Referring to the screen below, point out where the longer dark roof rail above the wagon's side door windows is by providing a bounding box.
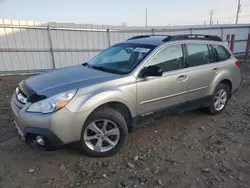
[163,34,222,42]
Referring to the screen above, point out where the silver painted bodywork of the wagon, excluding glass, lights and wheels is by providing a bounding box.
[12,39,241,143]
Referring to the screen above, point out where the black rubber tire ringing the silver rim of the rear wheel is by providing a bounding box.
[208,83,230,115]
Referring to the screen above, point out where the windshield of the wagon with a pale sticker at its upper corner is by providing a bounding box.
[88,44,154,74]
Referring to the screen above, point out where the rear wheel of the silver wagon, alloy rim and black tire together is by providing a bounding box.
[209,83,230,115]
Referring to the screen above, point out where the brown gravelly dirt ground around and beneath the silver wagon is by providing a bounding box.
[0,64,250,188]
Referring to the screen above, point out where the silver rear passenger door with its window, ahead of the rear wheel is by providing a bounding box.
[185,42,219,105]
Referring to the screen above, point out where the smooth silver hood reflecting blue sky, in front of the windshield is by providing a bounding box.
[22,65,121,97]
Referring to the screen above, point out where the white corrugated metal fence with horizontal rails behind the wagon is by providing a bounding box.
[0,19,250,75]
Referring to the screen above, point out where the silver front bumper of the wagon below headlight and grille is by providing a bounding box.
[11,94,90,147]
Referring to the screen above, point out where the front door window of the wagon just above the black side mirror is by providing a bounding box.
[150,45,184,72]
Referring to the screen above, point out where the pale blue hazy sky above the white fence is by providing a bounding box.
[0,0,250,26]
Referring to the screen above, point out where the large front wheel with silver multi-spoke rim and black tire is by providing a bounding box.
[80,107,128,157]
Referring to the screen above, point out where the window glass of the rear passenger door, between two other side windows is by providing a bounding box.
[186,44,214,67]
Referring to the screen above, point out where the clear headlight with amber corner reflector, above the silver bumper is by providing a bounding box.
[27,90,77,114]
